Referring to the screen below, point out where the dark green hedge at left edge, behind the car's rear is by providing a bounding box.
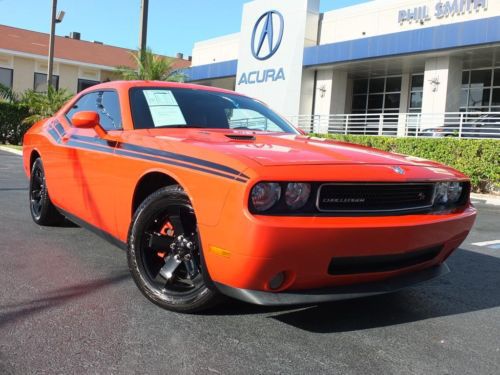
[0,101,29,145]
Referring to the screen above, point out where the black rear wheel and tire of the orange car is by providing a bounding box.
[29,158,64,226]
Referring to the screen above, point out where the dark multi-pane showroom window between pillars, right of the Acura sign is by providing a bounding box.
[352,76,401,114]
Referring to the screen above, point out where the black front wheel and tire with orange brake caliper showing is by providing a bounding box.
[127,185,220,313]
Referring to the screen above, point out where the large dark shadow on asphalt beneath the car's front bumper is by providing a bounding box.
[209,249,500,333]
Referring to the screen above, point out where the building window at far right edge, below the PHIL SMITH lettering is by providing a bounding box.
[460,67,500,112]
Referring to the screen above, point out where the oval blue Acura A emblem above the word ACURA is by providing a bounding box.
[252,10,285,60]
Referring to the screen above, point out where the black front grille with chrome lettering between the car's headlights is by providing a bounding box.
[316,183,434,213]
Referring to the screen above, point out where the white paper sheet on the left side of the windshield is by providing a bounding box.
[143,90,187,127]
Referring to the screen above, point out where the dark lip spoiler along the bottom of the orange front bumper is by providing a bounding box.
[215,263,450,306]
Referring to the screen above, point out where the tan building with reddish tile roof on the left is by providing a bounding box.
[0,25,191,93]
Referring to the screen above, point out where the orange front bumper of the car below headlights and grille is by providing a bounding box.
[199,206,476,294]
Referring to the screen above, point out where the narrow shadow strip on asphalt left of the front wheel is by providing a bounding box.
[0,271,130,328]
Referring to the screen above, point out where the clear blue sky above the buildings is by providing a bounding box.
[0,0,369,56]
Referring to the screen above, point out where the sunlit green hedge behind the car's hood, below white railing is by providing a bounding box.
[316,134,500,193]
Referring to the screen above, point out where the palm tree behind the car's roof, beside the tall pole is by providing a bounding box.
[117,48,186,82]
